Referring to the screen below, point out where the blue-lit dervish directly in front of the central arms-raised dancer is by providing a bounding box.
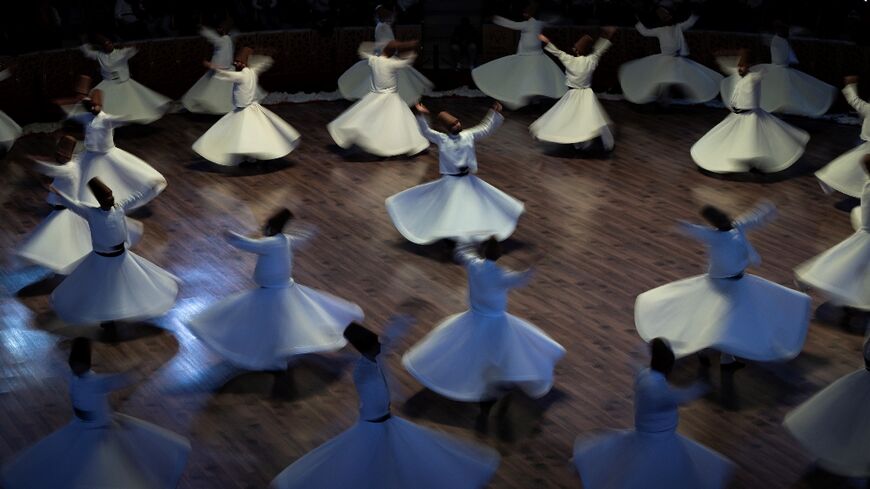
[402,238,565,404]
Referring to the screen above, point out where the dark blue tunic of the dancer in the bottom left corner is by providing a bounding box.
[69,370,129,427]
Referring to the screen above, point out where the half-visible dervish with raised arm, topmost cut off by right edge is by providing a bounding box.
[816,76,870,198]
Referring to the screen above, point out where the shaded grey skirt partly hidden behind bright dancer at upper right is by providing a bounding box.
[721,64,838,117]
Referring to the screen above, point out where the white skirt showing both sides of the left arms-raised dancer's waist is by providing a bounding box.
[17,209,144,275]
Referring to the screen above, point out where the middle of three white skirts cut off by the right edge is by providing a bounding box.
[795,230,870,310]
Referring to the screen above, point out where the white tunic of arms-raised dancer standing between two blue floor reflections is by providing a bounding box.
[57,190,147,253]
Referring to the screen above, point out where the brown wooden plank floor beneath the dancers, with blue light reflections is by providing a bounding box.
[0,98,862,489]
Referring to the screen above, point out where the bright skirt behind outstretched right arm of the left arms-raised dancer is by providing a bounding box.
[78,148,166,208]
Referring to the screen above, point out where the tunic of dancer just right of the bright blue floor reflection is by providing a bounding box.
[227,233,310,288]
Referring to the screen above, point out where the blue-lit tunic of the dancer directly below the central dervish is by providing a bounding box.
[456,246,532,316]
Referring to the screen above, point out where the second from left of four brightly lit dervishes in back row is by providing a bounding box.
[326,41,429,157]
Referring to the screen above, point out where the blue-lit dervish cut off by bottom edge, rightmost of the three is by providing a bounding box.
[573,338,734,489]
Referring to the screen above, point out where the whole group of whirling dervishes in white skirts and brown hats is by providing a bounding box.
[0,5,870,489]
